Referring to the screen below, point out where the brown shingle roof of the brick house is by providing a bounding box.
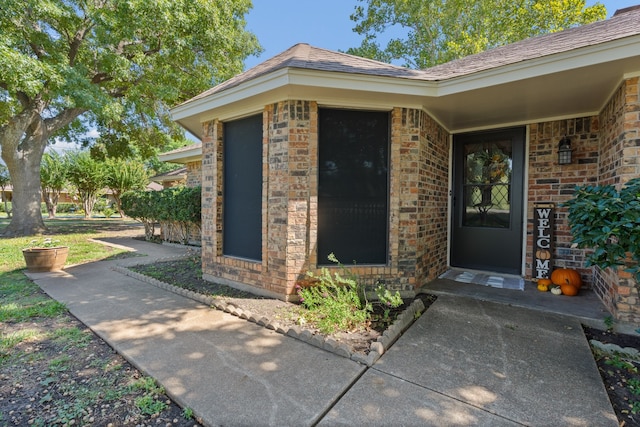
[183,8,640,105]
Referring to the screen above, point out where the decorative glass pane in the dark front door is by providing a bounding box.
[462,140,513,228]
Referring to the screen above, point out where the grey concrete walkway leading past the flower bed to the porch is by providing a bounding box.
[28,239,618,427]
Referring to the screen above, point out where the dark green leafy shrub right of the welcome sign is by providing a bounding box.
[564,178,640,283]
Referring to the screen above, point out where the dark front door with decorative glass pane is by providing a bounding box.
[451,128,525,274]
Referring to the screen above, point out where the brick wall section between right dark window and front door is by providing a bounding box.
[391,108,449,287]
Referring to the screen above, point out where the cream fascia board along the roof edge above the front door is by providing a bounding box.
[437,36,640,96]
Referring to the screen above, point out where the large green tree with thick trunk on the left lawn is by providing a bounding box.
[0,0,260,236]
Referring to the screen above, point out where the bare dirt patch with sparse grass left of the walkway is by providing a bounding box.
[0,304,198,427]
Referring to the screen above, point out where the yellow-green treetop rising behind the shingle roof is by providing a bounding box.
[348,0,606,68]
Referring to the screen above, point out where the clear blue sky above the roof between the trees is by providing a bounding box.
[245,0,640,69]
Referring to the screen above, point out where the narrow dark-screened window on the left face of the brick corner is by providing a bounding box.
[222,115,262,260]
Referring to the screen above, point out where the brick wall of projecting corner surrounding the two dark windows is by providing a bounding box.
[202,100,449,300]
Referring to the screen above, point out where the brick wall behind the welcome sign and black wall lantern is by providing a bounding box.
[526,117,600,284]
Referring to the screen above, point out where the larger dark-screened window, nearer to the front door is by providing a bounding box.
[318,109,389,264]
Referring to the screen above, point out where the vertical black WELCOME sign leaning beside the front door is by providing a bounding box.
[533,203,555,279]
